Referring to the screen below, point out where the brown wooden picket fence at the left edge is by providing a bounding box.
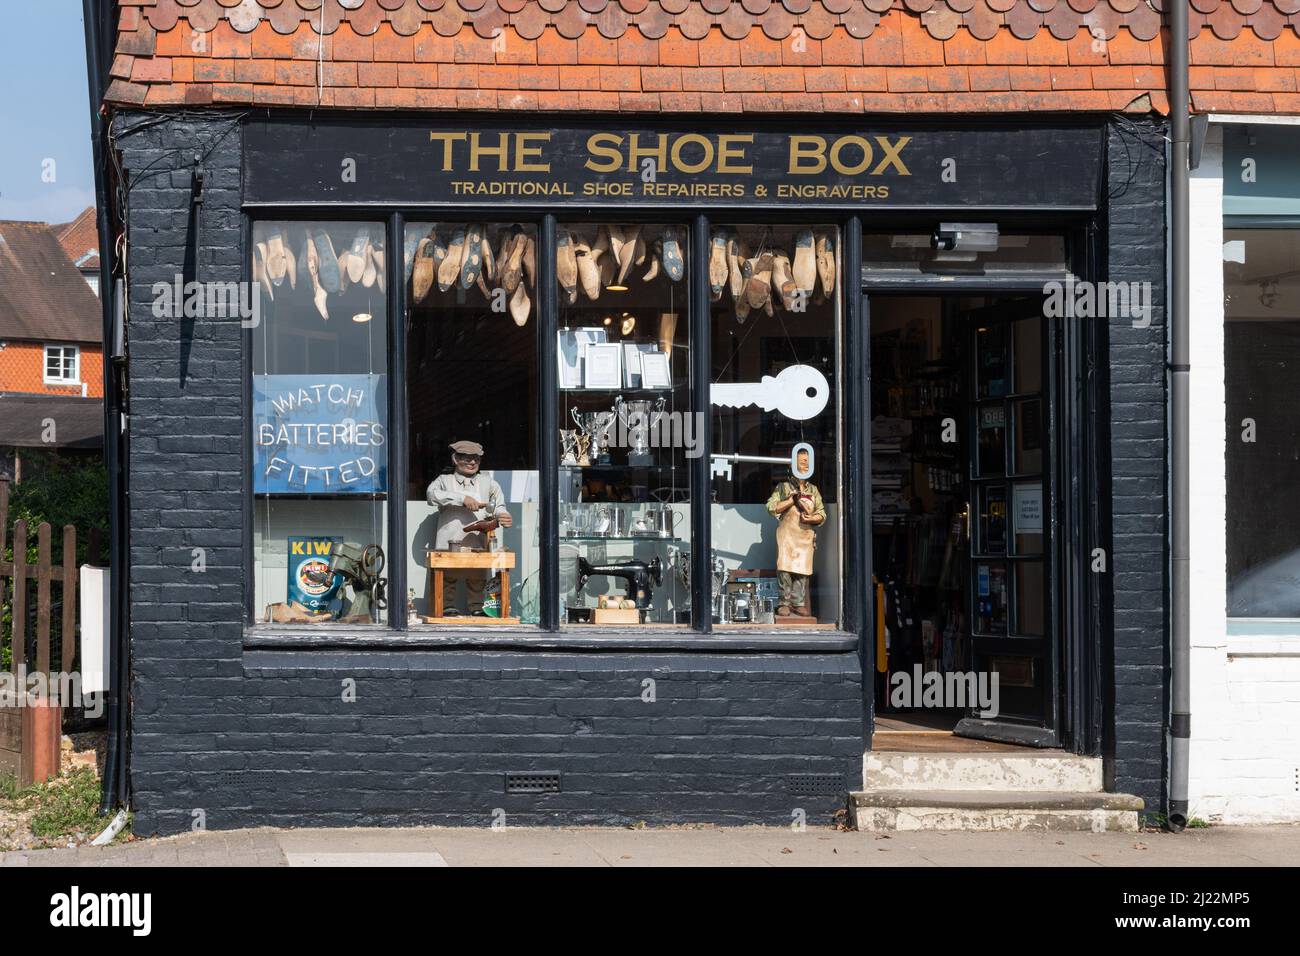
[0,479,99,786]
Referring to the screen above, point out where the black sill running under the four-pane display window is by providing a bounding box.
[244,624,858,654]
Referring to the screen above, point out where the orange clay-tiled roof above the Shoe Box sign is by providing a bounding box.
[109,0,1300,112]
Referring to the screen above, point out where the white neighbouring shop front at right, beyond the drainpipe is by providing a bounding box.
[1188,114,1300,823]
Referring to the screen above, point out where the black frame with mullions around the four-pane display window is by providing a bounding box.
[241,204,870,642]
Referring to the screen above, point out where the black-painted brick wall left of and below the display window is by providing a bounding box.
[117,108,862,834]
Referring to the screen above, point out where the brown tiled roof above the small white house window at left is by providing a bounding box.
[0,221,103,342]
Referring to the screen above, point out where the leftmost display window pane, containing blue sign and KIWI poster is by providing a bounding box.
[251,222,389,624]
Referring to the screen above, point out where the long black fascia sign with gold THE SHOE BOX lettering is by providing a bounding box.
[244,117,1102,209]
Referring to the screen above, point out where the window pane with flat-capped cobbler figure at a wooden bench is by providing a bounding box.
[403,222,540,626]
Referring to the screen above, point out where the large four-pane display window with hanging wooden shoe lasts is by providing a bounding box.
[252,219,842,636]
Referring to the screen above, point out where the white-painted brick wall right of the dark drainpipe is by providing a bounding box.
[1190,125,1300,823]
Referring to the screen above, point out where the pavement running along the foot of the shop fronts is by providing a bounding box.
[0,825,1300,866]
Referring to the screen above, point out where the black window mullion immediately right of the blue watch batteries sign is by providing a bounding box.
[384,213,405,631]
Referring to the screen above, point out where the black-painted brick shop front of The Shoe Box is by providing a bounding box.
[118,113,1165,831]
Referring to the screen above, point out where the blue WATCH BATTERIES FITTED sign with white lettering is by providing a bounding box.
[252,375,389,494]
